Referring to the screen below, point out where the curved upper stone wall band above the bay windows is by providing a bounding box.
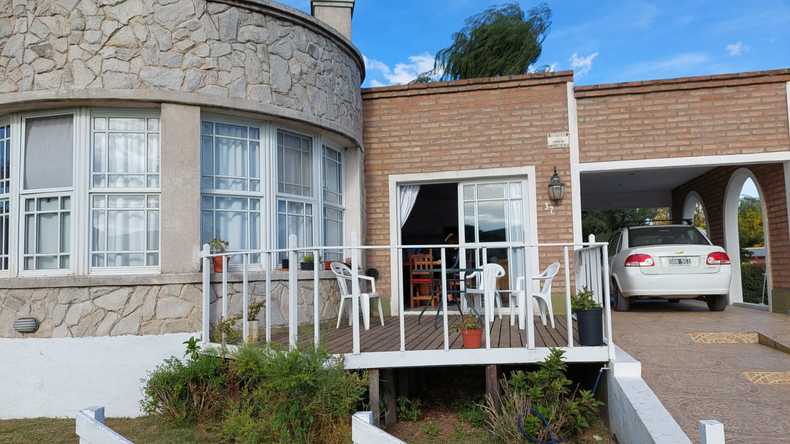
[0,0,362,141]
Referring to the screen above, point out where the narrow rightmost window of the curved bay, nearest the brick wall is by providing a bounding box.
[322,146,344,261]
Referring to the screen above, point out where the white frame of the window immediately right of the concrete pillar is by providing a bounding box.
[199,114,273,269]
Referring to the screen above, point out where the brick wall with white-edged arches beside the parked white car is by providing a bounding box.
[672,163,790,306]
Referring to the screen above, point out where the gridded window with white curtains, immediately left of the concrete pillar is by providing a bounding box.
[89,114,160,269]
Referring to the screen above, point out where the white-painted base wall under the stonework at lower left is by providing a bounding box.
[0,333,199,419]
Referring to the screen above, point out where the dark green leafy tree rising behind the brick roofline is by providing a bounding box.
[434,2,551,80]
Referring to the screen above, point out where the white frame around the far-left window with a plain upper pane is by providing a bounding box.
[16,109,85,277]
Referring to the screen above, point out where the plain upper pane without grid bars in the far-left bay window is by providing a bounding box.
[24,115,74,190]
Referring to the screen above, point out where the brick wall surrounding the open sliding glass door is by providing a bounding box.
[363,73,573,308]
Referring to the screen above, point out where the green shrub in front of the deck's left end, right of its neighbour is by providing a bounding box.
[223,347,366,443]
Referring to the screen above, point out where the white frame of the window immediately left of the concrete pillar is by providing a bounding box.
[89,108,163,275]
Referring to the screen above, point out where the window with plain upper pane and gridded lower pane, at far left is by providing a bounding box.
[20,114,74,271]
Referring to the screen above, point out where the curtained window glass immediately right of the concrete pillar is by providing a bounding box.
[201,121,265,260]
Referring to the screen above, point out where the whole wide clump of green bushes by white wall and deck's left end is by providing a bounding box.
[142,341,367,443]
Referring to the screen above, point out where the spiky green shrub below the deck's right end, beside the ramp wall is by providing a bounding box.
[485,349,602,442]
